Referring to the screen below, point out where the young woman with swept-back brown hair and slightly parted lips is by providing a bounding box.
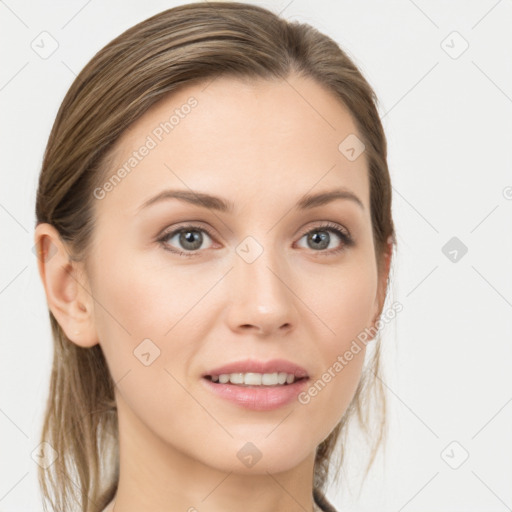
[35,2,395,512]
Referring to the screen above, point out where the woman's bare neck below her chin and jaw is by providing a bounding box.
[109,390,317,512]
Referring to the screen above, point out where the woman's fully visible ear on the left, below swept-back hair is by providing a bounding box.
[34,223,98,348]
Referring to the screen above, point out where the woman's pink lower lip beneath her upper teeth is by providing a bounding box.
[201,378,309,411]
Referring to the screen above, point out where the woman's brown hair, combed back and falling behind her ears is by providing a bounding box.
[36,2,396,512]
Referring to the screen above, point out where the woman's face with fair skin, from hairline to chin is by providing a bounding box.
[83,76,381,473]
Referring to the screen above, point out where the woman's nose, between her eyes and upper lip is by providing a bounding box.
[227,249,298,337]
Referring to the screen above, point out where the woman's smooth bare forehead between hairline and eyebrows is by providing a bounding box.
[97,76,369,219]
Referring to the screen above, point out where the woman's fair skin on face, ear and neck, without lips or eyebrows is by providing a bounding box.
[35,75,389,512]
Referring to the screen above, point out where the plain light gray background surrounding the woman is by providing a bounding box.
[0,0,512,512]
